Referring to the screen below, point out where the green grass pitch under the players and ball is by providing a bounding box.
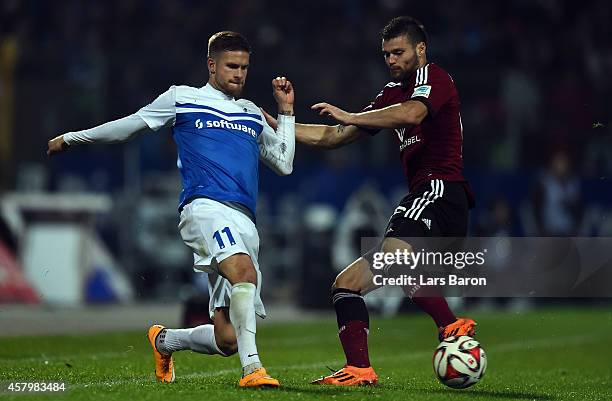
[0,308,612,401]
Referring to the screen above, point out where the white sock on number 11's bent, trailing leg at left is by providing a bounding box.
[155,324,224,355]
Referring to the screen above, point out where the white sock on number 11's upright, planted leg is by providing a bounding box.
[230,283,262,376]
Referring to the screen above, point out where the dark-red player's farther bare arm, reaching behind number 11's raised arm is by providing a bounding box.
[262,109,368,149]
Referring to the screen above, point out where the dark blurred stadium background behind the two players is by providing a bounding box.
[0,0,612,334]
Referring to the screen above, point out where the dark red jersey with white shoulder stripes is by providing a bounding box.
[364,63,473,203]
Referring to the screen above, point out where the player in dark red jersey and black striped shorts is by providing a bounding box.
[267,17,475,385]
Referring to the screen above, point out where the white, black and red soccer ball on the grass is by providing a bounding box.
[433,336,487,388]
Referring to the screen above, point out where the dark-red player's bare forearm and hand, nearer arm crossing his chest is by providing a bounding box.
[312,100,428,129]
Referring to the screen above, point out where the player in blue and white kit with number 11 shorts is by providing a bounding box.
[47,31,295,387]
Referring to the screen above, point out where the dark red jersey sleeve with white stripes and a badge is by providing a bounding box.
[410,65,455,117]
